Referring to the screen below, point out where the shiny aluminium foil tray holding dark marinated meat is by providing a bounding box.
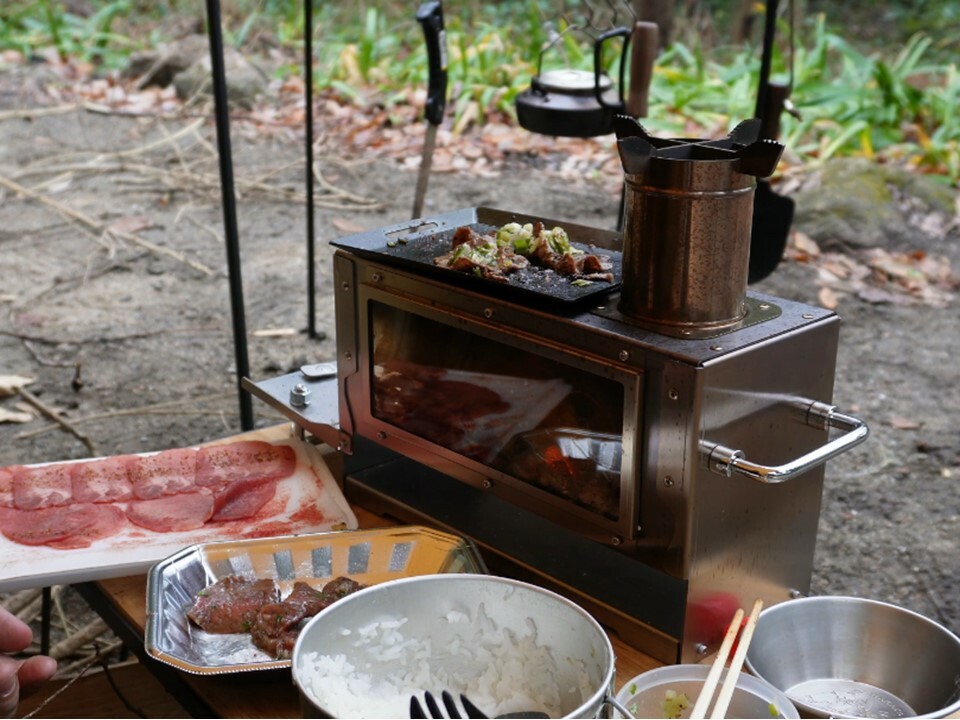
[144,526,487,675]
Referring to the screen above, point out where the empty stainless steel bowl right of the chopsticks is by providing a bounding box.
[747,597,960,718]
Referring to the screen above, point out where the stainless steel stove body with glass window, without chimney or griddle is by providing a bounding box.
[249,204,867,662]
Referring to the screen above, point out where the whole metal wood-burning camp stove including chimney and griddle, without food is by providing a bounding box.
[245,120,868,662]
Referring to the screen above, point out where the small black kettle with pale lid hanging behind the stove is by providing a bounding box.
[517,27,631,137]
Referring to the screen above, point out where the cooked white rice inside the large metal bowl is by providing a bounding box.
[299,604,594,718]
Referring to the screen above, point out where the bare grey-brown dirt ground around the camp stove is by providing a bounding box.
[0,76,960,676]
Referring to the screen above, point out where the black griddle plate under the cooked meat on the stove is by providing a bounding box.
[331,207,623,305]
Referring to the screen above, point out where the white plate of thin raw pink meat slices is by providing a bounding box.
[0,426,357,592]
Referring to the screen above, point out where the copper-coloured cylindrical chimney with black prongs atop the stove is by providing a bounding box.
[615,116,783,337]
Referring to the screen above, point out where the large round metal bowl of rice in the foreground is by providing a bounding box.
[293,574,615,717]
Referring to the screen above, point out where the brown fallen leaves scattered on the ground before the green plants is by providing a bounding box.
[7,52,960,309]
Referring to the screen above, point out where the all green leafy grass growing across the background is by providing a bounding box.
[0,0,960,184]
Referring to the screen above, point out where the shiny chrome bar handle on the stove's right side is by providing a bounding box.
[700,401,870,485]
